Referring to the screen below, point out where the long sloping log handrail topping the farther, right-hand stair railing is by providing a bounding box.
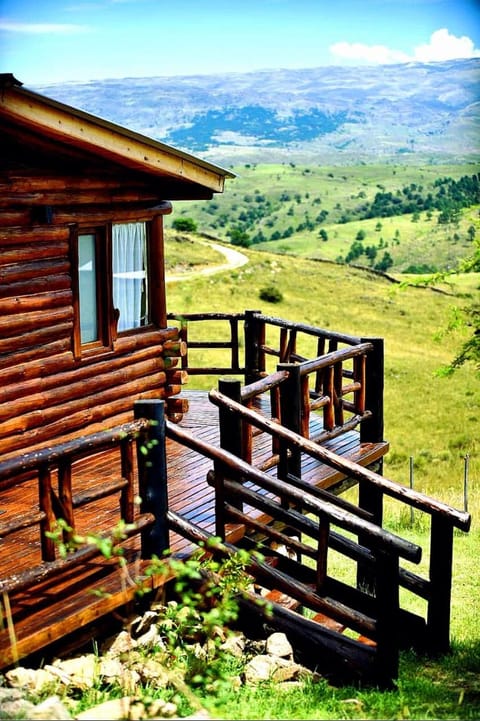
[208,389,471,531]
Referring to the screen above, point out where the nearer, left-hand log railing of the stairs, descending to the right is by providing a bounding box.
[166,414,421,685]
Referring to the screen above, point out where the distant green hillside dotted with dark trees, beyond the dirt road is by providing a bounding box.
[167,163,480,273]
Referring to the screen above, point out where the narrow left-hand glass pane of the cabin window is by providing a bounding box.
[78,233,98,343]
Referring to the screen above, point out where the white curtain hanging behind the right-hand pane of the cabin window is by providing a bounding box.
[112,223,148,331]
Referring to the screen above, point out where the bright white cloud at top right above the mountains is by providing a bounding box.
[330,28,480,65]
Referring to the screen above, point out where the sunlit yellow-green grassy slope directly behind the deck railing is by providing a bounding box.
[166,234,480,506]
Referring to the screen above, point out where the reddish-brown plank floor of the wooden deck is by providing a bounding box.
[0,391,388,667]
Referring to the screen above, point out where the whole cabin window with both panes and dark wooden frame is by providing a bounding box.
[72,219,159,357]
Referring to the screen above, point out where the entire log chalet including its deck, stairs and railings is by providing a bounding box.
[0,75,470,684]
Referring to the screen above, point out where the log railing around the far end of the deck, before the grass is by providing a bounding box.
[169,310,384,450]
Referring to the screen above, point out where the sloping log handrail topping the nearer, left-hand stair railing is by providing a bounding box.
[165,420,421,563]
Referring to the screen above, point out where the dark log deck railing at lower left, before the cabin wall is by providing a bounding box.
[0,414,163,592]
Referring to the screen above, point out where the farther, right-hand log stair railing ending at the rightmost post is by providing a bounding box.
[209,390,471,652]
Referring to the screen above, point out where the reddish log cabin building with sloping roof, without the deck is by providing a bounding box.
[0,75,233,456]
